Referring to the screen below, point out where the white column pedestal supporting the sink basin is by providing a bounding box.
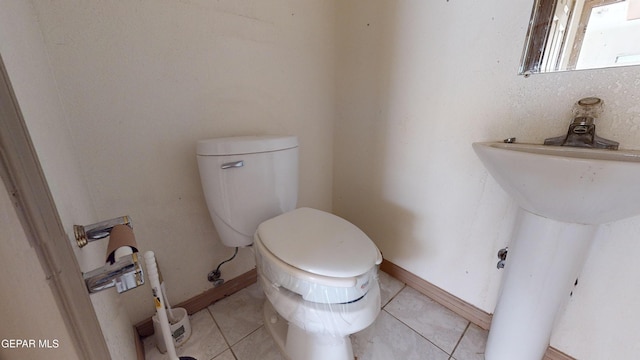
[485,209,598,360]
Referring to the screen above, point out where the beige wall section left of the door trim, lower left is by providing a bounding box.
[0,180,79,360]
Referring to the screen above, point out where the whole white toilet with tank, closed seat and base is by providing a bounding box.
[197,136,382,360]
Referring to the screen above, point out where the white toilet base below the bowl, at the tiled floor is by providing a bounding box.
[263,299,354,360]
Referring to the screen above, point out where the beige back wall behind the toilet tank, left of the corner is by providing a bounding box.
[34,0,335,322]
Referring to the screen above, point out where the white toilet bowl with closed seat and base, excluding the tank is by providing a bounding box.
[254,208,382,360]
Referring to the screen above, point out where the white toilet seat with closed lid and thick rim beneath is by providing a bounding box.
[254,208,382,303]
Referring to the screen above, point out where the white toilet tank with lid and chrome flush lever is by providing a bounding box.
[197,136,298,247]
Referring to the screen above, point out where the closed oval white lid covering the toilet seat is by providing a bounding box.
[256,208,382,277]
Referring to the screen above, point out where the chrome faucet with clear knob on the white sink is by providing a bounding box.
[544,97,619,150]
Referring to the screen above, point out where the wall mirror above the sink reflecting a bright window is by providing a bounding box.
[519,0,640,76]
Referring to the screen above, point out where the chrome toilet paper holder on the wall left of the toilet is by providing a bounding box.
[73,216,144,293]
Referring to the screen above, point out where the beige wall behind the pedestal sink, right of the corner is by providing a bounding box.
[333,0,640,360]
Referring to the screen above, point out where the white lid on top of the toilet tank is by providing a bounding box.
[196,135,298,156]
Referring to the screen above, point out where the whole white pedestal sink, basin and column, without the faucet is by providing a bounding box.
[473,142,640,360]
